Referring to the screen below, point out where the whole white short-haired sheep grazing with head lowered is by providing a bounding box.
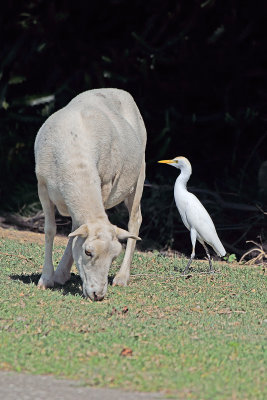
[35,89,146,300]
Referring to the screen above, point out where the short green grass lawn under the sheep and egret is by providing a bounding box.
[0,239,267,400]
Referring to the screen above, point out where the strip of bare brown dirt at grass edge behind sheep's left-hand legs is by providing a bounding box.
[0,227,68,246]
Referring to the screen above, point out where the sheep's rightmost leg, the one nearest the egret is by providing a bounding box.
[113,158,145,286]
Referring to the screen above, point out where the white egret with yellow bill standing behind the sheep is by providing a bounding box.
[158,157,226,274]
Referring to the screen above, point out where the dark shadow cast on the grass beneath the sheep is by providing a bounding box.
[10,273,114,297]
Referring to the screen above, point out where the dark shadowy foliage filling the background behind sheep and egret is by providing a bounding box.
[0,0,267,252]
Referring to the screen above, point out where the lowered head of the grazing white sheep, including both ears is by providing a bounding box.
[69,223,140,301]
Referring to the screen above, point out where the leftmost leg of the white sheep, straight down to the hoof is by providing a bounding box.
[38,183,56,289]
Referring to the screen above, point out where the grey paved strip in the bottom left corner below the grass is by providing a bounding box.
[0,371,164,400]
